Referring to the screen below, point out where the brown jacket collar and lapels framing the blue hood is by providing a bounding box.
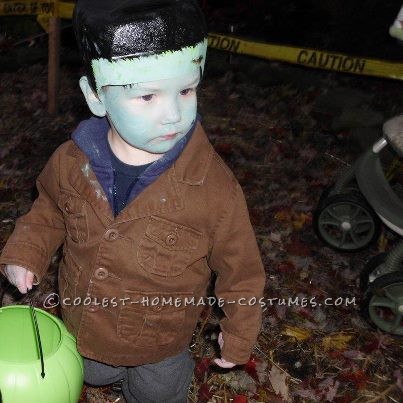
[67,122,214,226]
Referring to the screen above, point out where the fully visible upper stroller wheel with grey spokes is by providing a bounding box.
[313,192,380,252]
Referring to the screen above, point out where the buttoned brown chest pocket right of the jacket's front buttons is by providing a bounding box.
[137,217,202,277]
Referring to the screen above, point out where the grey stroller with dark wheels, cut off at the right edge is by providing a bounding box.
[313,116,403,336]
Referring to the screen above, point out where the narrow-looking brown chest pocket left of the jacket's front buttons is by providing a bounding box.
[58,193,88,243]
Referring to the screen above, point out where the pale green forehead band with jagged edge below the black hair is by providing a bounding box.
[92,39,207,92]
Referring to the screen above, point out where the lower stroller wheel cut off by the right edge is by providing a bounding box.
[361,271,403,336]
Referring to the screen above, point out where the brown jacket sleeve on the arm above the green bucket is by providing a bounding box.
[0,151,65,282]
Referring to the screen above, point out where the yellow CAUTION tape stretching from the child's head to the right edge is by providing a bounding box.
[209,33,403,80]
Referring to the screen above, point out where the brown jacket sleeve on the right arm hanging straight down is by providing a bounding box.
[209,183,265,364]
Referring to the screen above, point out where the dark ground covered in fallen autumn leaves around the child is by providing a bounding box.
[0,52,403,403]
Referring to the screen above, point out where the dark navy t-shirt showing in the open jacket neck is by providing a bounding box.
[108,142,152,217]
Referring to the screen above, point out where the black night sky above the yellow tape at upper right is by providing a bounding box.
[205,0,403,59]
